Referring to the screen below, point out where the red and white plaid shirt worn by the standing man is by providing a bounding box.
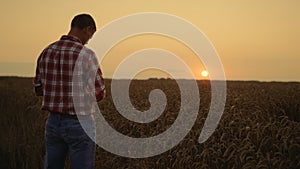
[33,35,105,115]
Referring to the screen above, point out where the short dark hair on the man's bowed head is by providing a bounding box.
[71,14,96,31]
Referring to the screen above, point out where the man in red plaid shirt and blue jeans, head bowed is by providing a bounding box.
[33,14,105,169]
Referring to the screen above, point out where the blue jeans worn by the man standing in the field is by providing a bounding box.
[44,114,96,169]
